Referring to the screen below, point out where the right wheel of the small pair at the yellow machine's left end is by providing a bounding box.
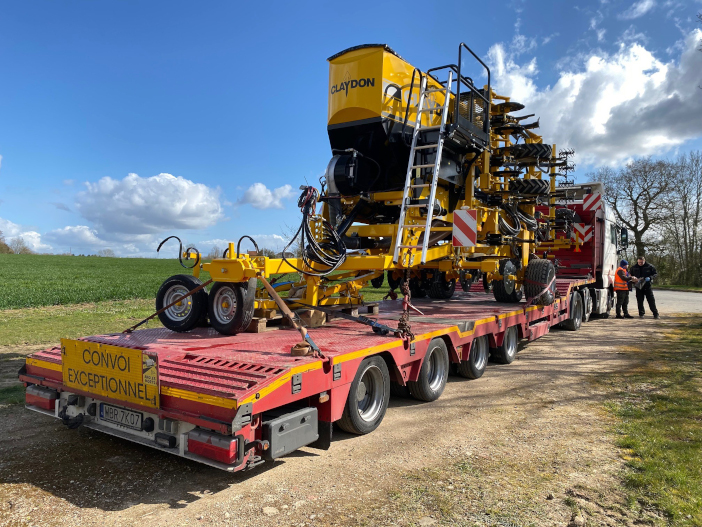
[208,278,256,335]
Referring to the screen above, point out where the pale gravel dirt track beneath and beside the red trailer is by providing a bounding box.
[0,292,702,527]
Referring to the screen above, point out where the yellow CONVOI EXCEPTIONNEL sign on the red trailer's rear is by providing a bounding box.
[61,339,159,408]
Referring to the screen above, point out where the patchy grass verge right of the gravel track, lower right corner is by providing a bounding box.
[608,317,702,525]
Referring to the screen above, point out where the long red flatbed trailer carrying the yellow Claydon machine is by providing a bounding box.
[19,276,595,471]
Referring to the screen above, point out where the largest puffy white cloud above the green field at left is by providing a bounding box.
[76,174,224,235]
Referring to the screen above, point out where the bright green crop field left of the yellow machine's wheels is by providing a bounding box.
[0,254,209,309]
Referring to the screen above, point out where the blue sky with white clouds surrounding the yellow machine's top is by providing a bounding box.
[0,0,702,256]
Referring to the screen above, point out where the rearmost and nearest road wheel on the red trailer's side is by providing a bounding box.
[337,356,390,434]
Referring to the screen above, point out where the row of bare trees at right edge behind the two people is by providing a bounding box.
[588,150,702,286]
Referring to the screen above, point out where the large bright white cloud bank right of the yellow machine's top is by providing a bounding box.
[488,29,702,165]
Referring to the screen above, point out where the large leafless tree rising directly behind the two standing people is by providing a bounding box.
[588,157,672,255]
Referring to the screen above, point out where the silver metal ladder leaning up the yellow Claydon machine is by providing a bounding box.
[392,71,453,267]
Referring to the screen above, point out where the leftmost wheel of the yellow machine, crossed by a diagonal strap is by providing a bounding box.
[156,274,207,332]
